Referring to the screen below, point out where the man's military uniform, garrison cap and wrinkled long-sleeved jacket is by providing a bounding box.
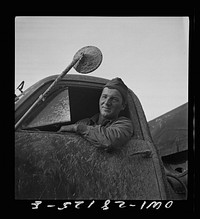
[58,78,133,149]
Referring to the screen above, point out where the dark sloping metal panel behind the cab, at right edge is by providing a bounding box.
[149,103,188,156]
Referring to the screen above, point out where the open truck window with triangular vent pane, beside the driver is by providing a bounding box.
[22,86,129,131]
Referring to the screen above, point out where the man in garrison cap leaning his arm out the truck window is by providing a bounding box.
[59,78,133,149]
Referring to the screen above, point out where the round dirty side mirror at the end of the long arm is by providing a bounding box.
[74,46,102,74]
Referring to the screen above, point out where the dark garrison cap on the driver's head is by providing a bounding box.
[104,78,128,104]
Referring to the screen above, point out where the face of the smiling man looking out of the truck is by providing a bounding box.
[99,87,125,119]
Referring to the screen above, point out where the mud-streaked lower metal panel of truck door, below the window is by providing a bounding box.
[15,131,162,200]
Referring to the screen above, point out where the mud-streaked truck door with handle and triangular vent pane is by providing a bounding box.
[15,81,170,200]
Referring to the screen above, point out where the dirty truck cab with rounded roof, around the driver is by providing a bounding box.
[15,74,183,200]
